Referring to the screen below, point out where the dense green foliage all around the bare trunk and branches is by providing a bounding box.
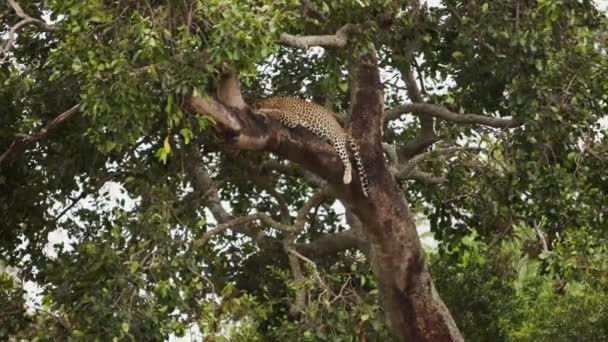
[0,0,608,341]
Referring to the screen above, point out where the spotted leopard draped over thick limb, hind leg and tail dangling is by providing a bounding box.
[256,97,369,196]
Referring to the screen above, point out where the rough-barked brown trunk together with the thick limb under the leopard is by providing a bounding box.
[188,65,462,341]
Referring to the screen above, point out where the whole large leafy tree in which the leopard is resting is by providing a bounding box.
[0,0,608,341]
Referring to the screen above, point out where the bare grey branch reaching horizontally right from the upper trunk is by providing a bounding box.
[386,103,523,128]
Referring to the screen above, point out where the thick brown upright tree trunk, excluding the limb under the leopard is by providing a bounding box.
[349,53,463,342]
